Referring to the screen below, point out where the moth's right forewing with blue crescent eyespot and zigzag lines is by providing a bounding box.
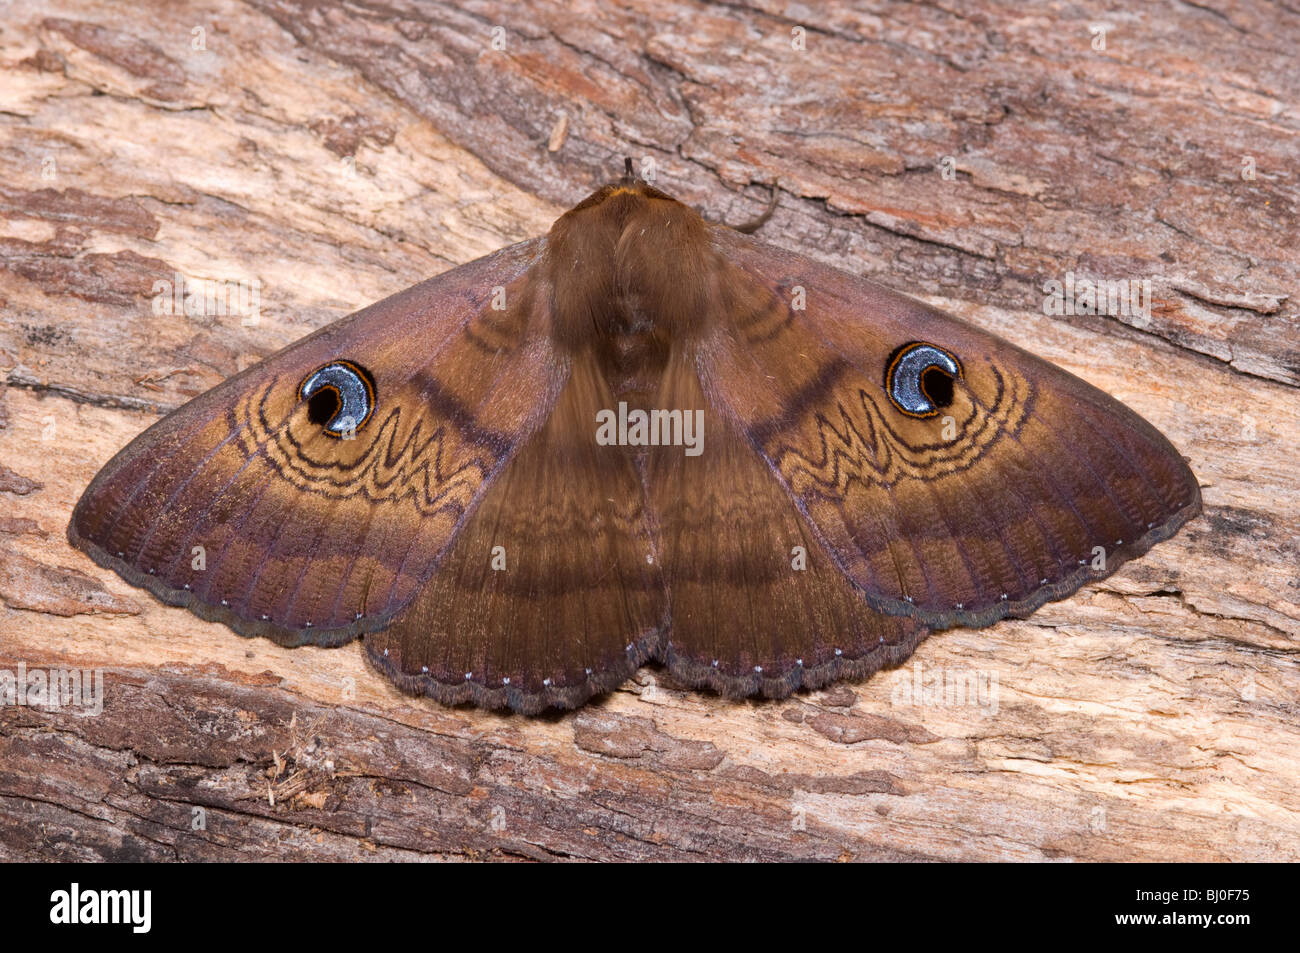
[697,228,1200,627]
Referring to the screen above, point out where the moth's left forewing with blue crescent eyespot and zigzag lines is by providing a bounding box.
[68,239,563,645]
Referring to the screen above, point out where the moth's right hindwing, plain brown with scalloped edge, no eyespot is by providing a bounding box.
[647,348,927,698]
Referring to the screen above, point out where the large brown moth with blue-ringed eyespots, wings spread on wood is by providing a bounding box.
[68,161,1200,714]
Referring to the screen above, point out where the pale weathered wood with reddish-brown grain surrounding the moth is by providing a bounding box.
[0,0,1300,861]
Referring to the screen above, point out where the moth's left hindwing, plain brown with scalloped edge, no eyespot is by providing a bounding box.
[365,354,666,714]
